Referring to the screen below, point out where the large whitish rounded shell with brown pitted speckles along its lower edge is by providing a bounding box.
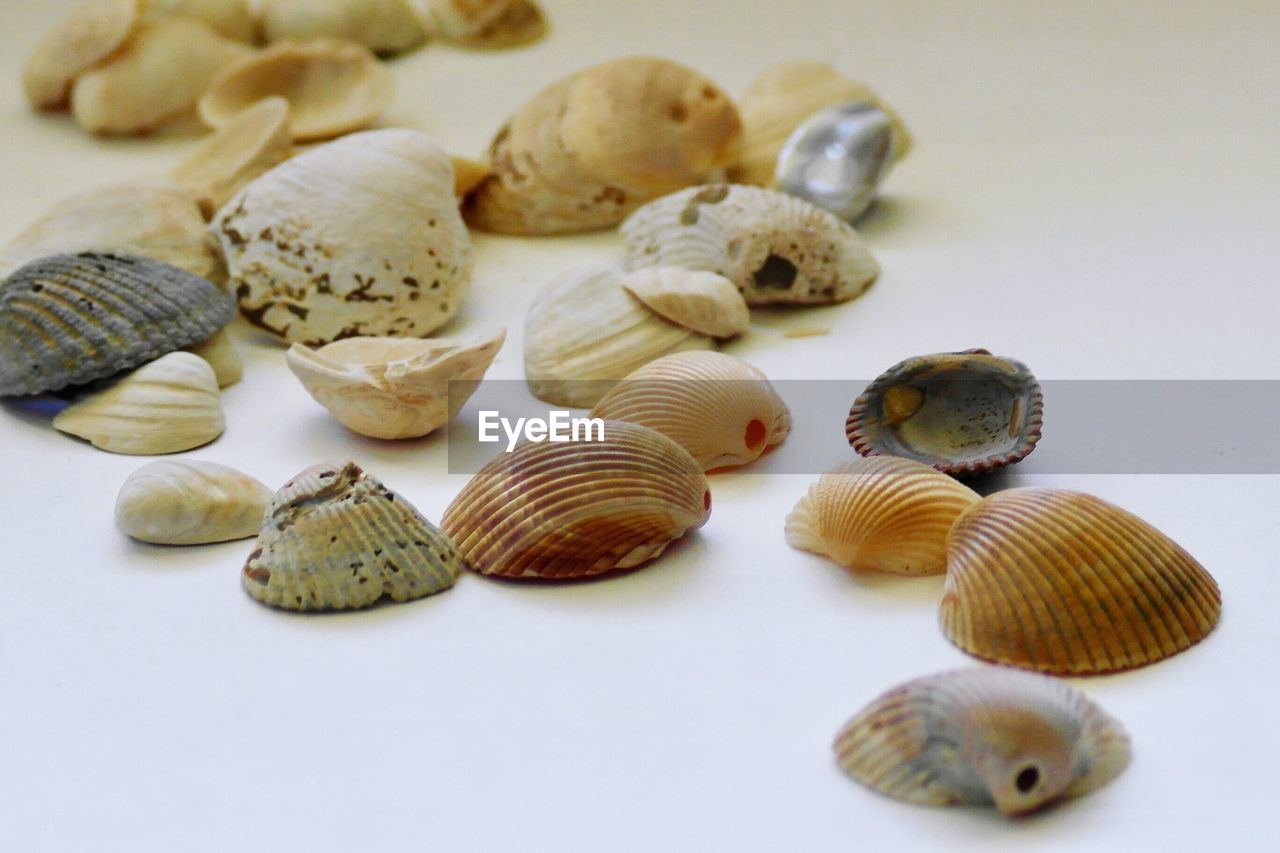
[211,129,472,346]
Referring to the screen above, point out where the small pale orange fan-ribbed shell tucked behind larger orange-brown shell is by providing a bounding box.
[786,456,982,575]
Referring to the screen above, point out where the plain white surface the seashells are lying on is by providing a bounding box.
[0,0,1280,850]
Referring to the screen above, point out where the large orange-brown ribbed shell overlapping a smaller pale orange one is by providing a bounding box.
[942,488,1222,675]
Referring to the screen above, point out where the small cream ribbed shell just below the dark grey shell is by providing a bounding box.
[54,352,227,456]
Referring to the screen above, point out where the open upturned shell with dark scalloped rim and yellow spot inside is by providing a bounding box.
[845,350,1043,475]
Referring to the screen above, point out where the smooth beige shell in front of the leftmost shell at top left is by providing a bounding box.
[72,15,252,134]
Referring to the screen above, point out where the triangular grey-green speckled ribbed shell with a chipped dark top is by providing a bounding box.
[241,462,462,611]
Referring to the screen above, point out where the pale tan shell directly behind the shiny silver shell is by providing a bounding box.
[728,60,911,187]
